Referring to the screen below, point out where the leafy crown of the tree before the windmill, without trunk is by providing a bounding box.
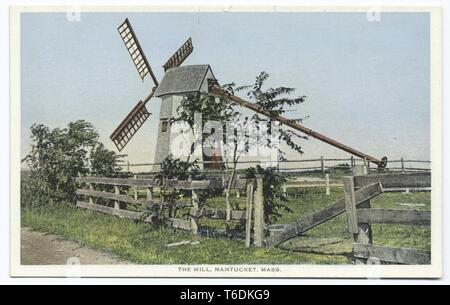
[171,72,308,163]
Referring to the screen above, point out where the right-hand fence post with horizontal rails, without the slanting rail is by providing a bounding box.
[343,173,431,265]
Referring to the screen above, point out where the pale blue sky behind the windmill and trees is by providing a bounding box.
[21,12,430,167]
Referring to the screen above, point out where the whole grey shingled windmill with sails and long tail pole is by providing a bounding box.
[110,18,387,168]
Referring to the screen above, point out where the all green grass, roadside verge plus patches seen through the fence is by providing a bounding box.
[21,180,431,264]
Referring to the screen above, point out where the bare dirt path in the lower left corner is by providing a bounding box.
[20,228,128,265]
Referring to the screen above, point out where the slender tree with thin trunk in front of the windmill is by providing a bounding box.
[171,72,308,220]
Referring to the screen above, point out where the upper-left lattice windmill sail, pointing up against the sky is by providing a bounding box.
[117,18,158,86]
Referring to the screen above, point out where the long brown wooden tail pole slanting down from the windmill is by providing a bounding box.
[210,87,386,167]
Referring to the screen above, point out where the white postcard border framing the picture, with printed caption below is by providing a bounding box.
[10,6,443,278]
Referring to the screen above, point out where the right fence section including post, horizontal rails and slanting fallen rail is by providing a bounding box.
[264,173,431,264]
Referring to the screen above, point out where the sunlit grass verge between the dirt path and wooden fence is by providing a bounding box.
[22,207,348,264]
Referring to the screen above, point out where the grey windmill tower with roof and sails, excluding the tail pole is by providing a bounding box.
[110,19,221,168]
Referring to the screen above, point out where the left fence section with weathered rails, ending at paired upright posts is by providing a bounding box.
[76,177,265,246]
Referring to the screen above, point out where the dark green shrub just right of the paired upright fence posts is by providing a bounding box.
[246,165,292,224]
